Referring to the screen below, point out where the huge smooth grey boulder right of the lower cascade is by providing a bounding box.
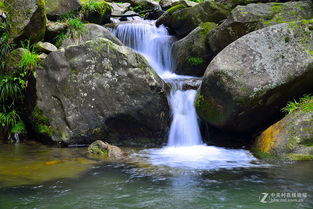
[195,20,313,133]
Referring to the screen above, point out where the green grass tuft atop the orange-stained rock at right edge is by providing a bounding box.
[282,94,313,114]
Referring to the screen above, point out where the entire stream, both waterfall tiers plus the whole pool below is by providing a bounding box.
[0,21,313,209]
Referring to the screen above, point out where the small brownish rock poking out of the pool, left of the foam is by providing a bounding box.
[88,140,124,159]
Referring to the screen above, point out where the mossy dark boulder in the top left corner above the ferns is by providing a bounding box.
[5,0,47,44]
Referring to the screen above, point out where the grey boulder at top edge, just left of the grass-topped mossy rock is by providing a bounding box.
[46,0,82,20]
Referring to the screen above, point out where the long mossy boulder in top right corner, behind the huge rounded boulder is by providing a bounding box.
[208,1,313,55]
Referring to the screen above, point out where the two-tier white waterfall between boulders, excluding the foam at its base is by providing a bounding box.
[114,21,202,146]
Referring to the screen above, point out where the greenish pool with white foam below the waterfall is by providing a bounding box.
[0,141,313,209]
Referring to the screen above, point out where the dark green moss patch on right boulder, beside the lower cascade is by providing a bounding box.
[195,95,222,123]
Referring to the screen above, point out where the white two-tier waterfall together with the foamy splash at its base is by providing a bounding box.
[114,21,256,169]
